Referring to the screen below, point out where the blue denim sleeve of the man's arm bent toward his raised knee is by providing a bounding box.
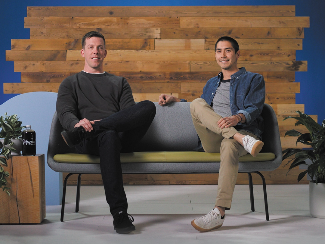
[238,74,265,124]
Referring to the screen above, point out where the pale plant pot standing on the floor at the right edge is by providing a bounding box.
[309,181,325,218]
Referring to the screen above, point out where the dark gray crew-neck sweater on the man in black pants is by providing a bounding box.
[56,71,135,130]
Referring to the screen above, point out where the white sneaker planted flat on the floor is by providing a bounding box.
[191,208,225,232]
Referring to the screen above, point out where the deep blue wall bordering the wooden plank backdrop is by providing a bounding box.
[0,0,325,204]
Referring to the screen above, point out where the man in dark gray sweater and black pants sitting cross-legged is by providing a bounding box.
[56,31,156,234]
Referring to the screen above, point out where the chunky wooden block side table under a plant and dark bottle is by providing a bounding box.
[0,154,46,224]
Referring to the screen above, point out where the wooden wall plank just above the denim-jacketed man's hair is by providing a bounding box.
[161,27,304,39]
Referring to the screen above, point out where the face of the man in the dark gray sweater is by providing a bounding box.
[81,37,107,73]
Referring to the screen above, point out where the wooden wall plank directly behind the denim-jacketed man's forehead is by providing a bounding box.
[204,38,302,50]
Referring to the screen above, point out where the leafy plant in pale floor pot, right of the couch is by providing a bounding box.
[282,111,325,218]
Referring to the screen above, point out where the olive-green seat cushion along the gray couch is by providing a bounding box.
[53,151,275,164]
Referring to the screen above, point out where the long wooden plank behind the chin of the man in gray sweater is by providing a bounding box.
[14,61,189,73]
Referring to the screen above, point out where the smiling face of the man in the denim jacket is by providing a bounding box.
[216,41,239,71]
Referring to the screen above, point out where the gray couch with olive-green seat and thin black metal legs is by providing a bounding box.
[47,102,282,221]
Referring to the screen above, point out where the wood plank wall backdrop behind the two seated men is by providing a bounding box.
[3,6,310,184]
